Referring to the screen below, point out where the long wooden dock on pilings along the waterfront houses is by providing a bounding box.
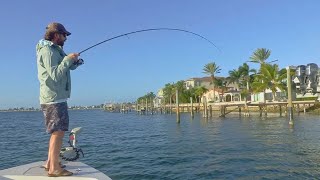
[107,100,319,118]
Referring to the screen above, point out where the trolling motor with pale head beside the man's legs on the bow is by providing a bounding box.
[60,127,84,161]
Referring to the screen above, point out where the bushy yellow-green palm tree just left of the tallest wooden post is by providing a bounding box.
[252,64,287,103]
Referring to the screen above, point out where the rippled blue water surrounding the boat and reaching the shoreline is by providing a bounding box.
[0,110,320,180]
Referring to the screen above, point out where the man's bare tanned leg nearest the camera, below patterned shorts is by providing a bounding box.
[48,131,64,174]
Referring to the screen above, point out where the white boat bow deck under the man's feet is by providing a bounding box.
[0,161,111,180]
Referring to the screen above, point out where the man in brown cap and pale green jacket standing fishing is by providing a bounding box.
[36,23,81,177]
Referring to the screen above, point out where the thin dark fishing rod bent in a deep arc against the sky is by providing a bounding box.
[79,28,221,54]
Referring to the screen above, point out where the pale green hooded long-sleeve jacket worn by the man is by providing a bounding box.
[36,39,77,104]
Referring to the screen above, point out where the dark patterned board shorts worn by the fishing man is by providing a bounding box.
[41,102,69,134]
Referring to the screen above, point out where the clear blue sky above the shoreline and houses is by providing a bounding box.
[0,0,320,109]
